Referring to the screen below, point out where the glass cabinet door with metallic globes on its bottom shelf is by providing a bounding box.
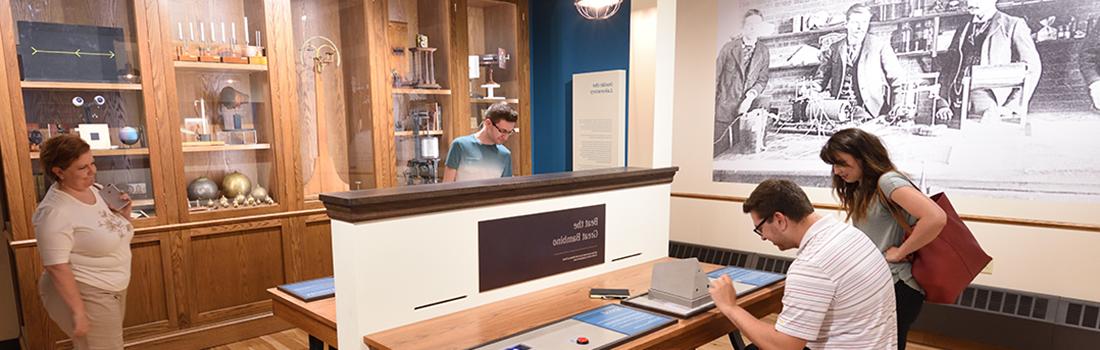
[162,0,281,217]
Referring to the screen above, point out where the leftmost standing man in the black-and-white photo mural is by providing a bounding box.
[714,9,771,156]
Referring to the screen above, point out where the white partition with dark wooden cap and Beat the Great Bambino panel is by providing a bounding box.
[320,167,695,349]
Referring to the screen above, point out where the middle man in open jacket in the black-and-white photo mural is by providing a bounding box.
[814,3,905,120]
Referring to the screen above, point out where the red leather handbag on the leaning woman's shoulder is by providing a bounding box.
[890,193,993,304]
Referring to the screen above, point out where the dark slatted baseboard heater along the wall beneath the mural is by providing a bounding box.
[669,241,1100,349]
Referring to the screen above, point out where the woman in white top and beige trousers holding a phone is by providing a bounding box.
[33,135,133,350]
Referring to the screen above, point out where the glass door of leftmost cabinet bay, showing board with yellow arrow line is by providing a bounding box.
[6,0,158,221]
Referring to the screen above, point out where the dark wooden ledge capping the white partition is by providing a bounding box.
[321,166,679,222]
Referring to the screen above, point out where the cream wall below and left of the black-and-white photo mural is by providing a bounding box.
[630,0,1100,302]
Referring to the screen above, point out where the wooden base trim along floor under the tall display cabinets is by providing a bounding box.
[125,311,294,350]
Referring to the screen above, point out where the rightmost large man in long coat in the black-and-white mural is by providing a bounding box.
[936,0,1043,120]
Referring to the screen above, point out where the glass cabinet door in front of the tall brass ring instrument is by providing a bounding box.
[290,0,375,201]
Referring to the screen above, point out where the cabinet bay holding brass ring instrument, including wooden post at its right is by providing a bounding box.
[290,0,395,192]
